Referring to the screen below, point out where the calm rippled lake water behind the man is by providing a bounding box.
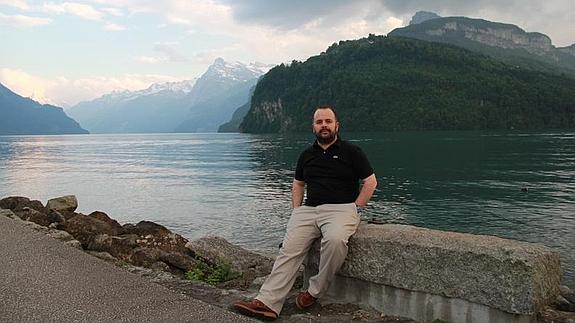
[0,131,575,287]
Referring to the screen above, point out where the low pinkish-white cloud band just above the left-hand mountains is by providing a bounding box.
[0,68,181,107]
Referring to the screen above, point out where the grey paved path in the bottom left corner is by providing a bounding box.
[0,216,253,322]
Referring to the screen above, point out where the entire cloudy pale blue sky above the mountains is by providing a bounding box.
[0,0,575,107]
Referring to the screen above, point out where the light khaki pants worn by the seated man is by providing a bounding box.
[256,203,360,314]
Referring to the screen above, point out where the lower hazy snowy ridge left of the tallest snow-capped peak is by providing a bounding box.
[68,80,195,133]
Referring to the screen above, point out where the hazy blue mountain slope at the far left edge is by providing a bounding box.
[0,84,88,135]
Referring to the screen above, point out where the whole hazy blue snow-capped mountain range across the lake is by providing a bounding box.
[67,58,272,133]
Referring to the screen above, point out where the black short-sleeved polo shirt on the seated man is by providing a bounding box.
[295,138,373,206]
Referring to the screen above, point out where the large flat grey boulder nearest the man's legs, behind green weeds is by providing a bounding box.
[186,237,273,288]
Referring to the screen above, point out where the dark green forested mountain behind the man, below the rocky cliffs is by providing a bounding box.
[240,34,575,133]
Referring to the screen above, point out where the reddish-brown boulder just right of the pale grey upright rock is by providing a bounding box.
[64,214,118,248]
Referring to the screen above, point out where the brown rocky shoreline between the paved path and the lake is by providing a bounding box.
[0,195,575,323]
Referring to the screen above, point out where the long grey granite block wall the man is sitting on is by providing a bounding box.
[305,224,561,322]
